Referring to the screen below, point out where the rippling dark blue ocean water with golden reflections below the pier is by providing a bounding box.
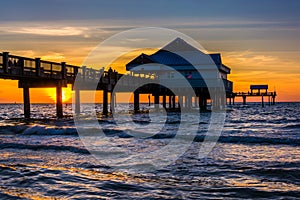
[0,103,300,199]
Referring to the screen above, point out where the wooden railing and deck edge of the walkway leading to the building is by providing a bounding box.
[0,52,155,86]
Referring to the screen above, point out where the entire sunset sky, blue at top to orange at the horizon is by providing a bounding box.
[0,0,300,103]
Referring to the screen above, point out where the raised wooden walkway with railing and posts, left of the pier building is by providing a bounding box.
[0,52,155,118]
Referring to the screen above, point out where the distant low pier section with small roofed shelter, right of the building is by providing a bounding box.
[229,85,277,107]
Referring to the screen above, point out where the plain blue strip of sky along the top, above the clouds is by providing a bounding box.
[0,0,300,23]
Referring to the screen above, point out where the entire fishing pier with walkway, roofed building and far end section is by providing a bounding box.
[0,38,276,118]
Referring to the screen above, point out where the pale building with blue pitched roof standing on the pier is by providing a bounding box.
[126,38,232,109]
